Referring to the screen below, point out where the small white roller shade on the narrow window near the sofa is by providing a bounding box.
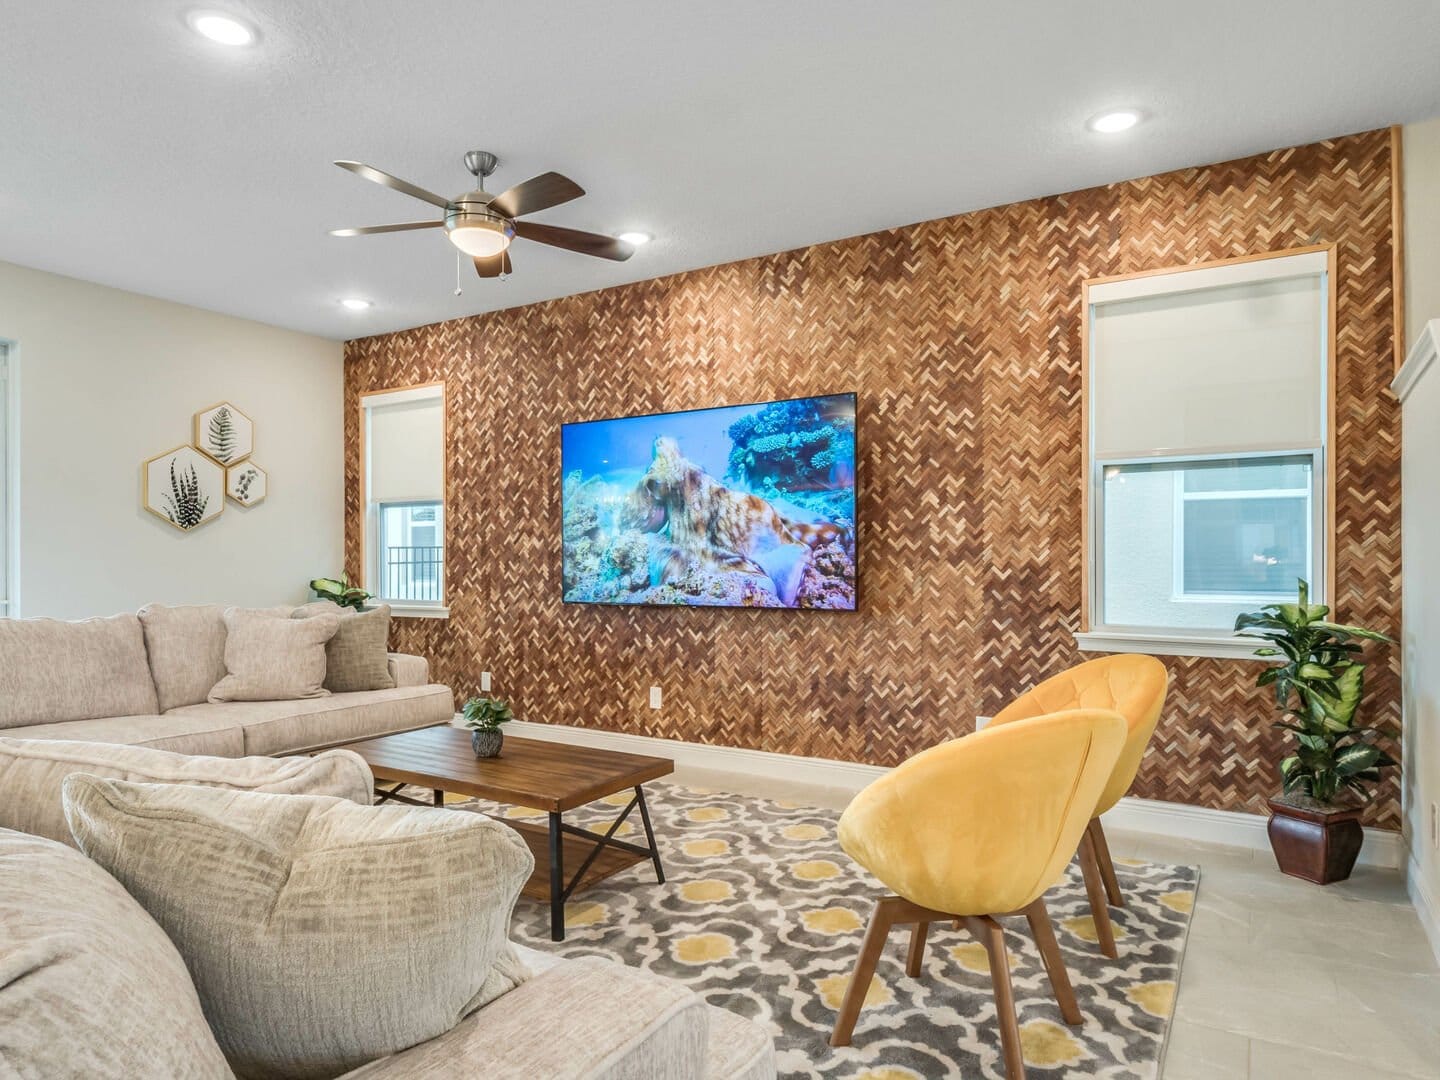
[361,386,445,503]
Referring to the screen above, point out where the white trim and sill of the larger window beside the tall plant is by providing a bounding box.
[1074,248,1335,662]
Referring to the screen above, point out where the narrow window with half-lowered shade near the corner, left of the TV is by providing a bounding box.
[360,384,446,616]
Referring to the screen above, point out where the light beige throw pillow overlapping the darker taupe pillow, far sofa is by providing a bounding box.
[209,608,340,701]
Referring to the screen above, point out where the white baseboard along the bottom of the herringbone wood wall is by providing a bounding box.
[505,720,1405,870]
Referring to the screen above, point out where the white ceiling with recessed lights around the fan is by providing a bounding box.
[0,0,1440,338]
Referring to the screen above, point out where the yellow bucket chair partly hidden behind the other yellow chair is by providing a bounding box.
[986,654,1169,959]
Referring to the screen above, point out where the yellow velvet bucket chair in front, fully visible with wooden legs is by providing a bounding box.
[829,708,1126,1079]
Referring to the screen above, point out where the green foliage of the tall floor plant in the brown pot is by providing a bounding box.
[1236,579,1397,805]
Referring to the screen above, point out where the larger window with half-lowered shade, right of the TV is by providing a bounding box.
[1079,251,1331,655]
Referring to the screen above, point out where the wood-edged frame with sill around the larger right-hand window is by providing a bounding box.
[1074,243,1336,660]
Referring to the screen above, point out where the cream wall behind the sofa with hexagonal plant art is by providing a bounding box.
[0,262,344,618]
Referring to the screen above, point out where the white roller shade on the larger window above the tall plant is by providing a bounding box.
[1089,253,1328,461]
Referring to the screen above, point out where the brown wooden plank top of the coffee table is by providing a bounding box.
[344,724,675,811]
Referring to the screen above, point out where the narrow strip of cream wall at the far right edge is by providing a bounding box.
[1397,120,1440,959]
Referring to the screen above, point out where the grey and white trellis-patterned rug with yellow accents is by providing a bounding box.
[410,783,1200,1080]
